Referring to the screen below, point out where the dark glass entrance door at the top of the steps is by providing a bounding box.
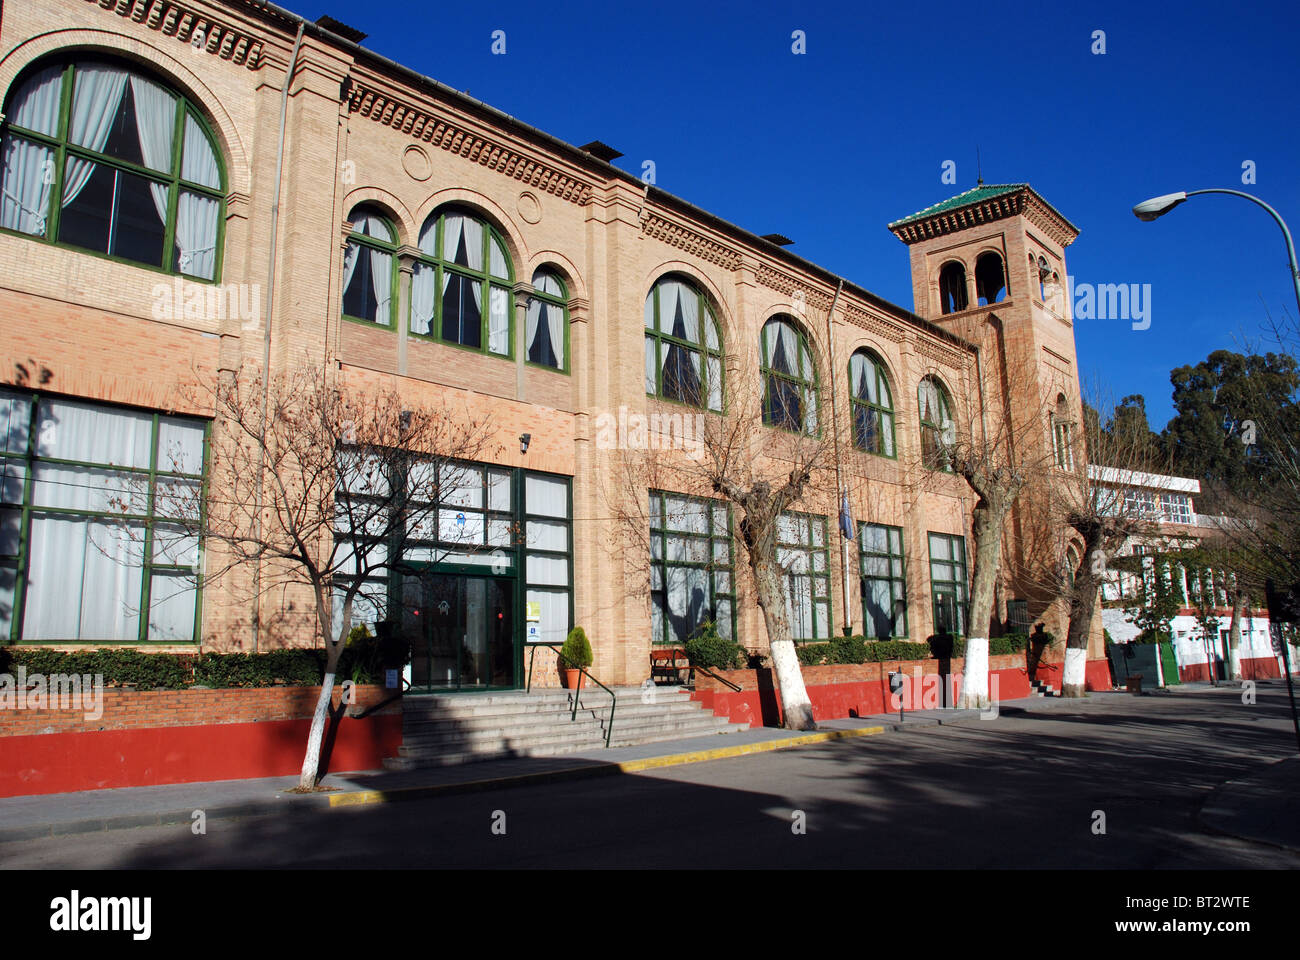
[402,572,516,691]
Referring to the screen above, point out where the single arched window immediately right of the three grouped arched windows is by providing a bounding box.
[645,277,723,412]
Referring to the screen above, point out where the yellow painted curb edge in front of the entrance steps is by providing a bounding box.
[329,727,885,807]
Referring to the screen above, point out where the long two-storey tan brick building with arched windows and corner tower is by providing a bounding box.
[0,0,1102,687]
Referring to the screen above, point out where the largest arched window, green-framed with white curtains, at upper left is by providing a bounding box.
[0,60,225,280]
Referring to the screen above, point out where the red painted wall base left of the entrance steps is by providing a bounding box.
[0,714,402,796]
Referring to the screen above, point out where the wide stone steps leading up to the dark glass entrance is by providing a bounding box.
[384,687,748,770]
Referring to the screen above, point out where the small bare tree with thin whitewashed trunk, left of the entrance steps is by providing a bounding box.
[159,363,497,790]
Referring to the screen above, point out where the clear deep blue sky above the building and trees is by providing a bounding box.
[309,0,1300,429]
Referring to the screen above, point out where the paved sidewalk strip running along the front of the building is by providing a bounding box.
[0,693,1127,843]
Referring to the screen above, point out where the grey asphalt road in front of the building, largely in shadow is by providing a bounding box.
[0,687,1300,870]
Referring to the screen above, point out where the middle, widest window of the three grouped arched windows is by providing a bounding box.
[411,208,515,356]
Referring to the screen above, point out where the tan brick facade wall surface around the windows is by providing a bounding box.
[0,0,1101,696]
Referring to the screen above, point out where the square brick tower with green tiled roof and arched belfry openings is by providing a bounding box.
[889,183,1101,657]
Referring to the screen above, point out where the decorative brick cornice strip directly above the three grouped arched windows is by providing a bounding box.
[347,79,592,206]
